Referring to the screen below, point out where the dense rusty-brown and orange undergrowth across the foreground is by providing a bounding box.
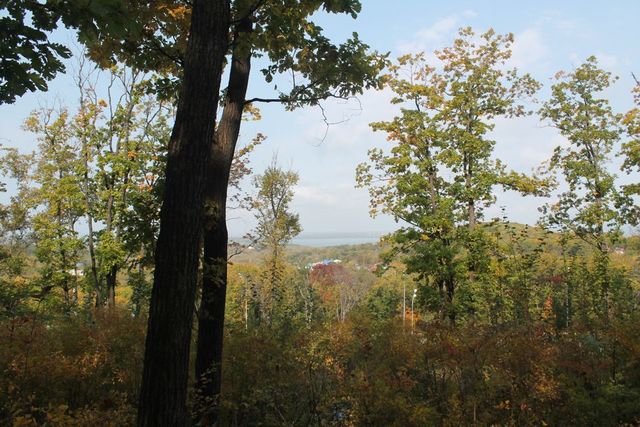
[0,300,640,426]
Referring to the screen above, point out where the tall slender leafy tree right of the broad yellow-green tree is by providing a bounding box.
[540,56,630,319]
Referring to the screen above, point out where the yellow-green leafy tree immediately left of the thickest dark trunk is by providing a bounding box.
[87,68,173,306]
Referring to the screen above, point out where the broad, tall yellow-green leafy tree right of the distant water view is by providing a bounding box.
[357,28,547,320]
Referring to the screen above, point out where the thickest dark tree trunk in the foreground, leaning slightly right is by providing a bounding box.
[138,0,230,426]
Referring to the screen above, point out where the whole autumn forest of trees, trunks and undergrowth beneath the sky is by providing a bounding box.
[0,0,640,426]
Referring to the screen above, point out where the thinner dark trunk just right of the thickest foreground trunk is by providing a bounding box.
[196,19,251,425]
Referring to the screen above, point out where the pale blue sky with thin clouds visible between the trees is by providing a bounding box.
[0,0,640,236]
